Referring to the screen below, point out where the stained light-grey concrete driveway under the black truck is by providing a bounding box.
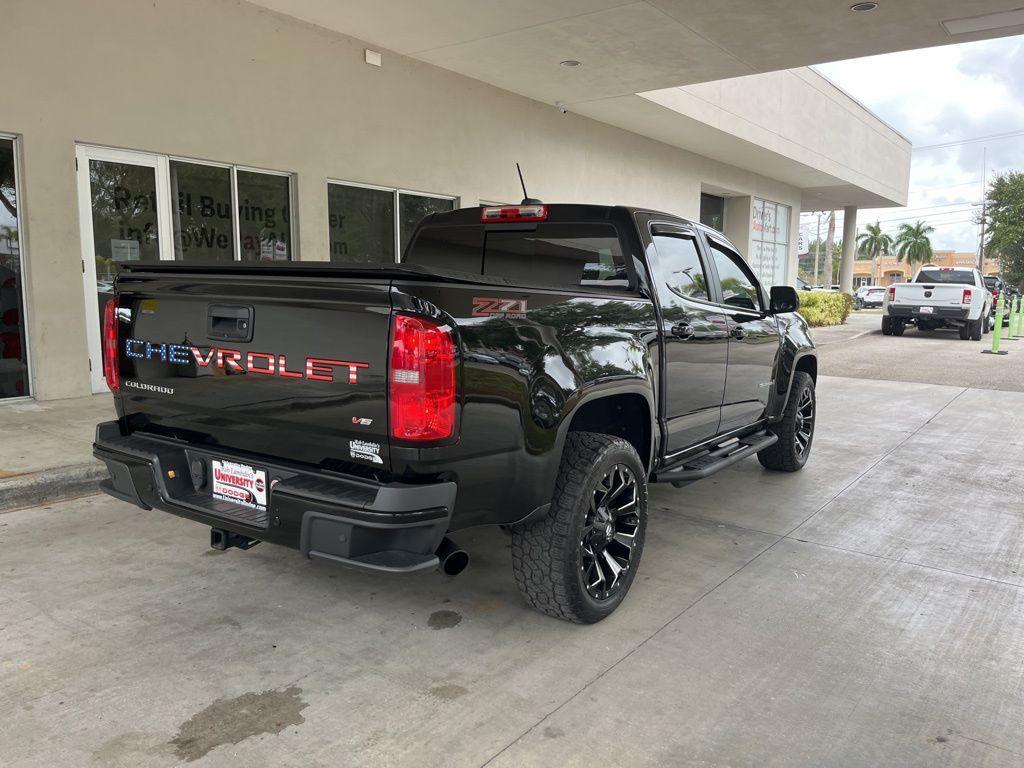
[0,374,1024,768]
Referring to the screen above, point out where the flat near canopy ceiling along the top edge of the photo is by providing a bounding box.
[243,0,1024,103]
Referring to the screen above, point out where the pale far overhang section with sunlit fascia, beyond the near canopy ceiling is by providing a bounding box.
[574,68,910,211]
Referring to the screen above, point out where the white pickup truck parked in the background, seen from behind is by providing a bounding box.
[882,264,992,341]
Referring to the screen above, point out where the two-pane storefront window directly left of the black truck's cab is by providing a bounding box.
[327,183,456,264]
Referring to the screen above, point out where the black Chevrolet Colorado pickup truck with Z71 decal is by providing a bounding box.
[94,202,817,623]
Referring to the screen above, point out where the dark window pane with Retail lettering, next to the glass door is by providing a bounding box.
[170,160,234,261]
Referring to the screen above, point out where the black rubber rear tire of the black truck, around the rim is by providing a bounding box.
[512,432,647,624]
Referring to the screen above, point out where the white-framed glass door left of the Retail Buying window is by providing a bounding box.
[76,146,174,392]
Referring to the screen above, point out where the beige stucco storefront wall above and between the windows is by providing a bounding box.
[8,0,800,398]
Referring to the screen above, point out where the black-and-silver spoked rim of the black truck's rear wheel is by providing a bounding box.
[580,464,640,600]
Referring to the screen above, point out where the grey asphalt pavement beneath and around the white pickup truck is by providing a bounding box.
[812,313,1024,392]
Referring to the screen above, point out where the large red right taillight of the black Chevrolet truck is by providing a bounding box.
[388,314,455,440]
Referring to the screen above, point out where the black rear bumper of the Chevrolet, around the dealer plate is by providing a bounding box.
[92,422,457,573]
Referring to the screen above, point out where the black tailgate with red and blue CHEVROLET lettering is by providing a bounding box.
[118,267,391,469]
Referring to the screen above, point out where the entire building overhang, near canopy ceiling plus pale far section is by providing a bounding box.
[241,0,1024,210]
